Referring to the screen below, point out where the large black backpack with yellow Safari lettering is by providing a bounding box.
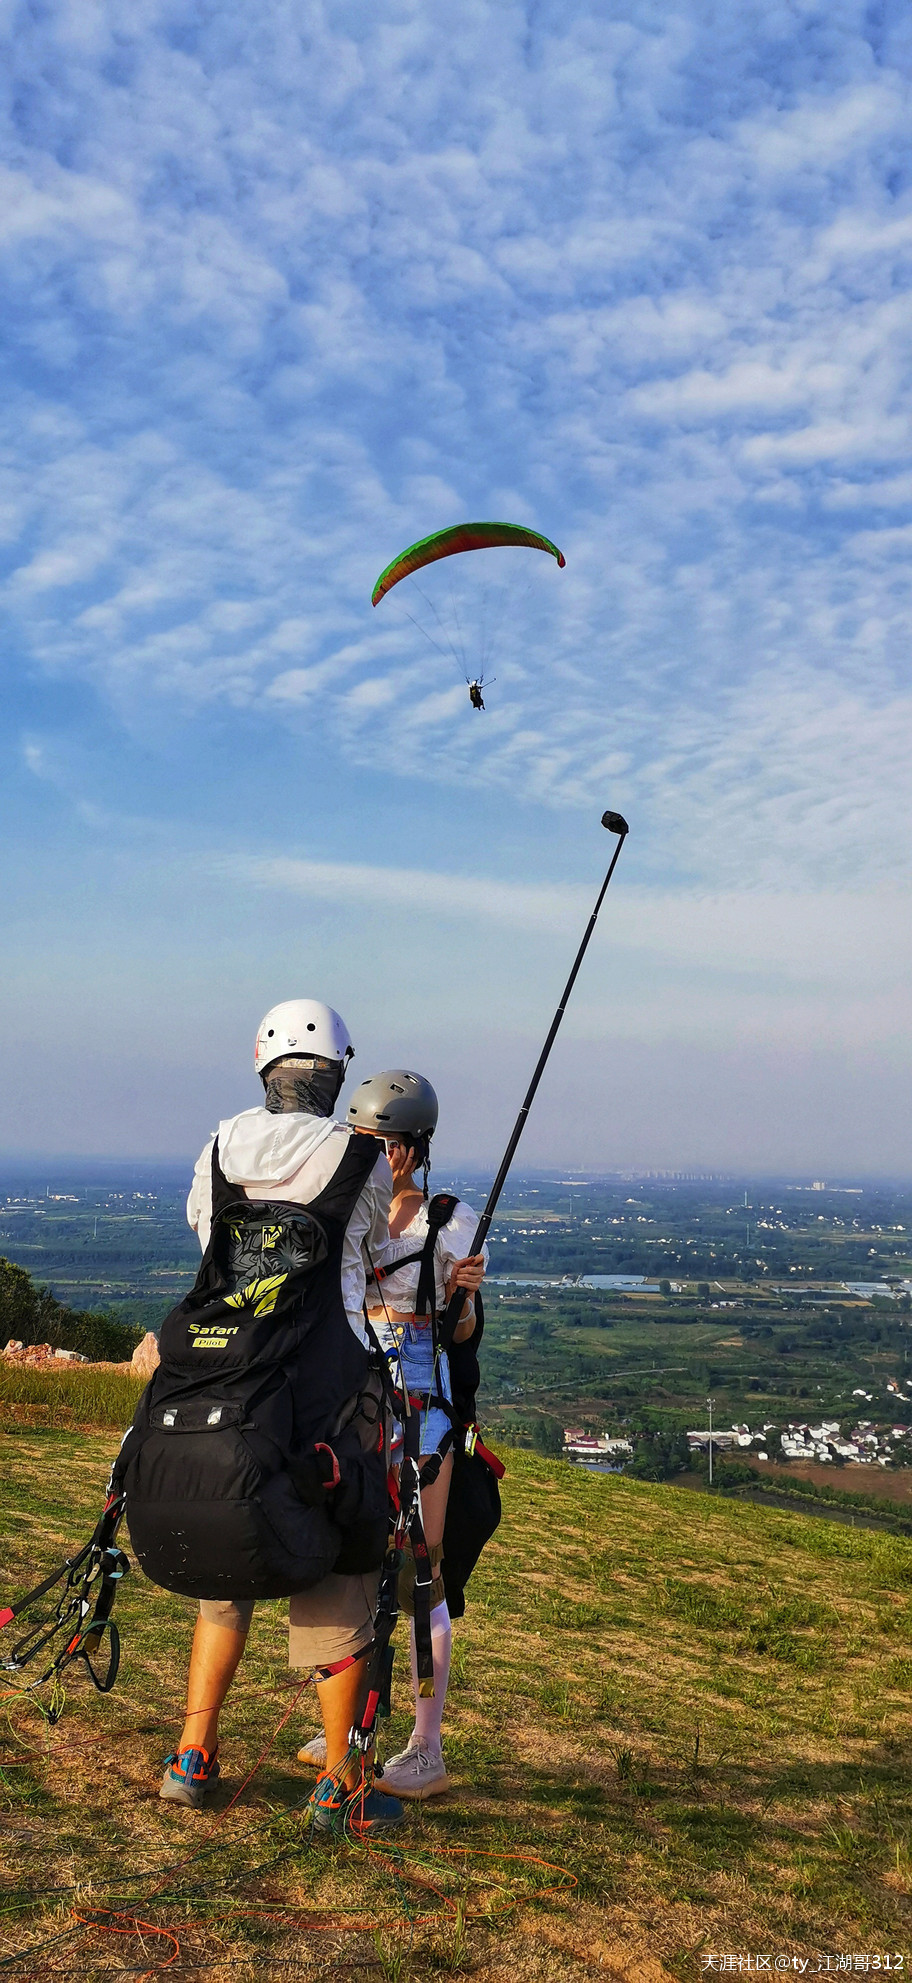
[115,1136,389,1598]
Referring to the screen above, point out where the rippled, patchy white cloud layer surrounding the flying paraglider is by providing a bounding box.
[0,0,912,886]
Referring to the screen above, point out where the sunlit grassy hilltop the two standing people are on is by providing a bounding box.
[0,1426,912,1983]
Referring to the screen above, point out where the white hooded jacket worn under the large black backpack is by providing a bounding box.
[186,1108,394,1344]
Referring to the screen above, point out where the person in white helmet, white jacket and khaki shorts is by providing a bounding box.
[161,999,412,1836]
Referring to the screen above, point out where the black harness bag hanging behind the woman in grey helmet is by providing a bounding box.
[442,1293,502,1618]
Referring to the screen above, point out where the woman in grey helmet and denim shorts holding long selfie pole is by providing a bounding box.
[301,1069,488,1799]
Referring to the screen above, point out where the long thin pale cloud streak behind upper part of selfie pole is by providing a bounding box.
[226,841,912,1049]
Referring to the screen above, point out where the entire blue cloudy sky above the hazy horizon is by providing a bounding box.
[0,0,912,1174]
